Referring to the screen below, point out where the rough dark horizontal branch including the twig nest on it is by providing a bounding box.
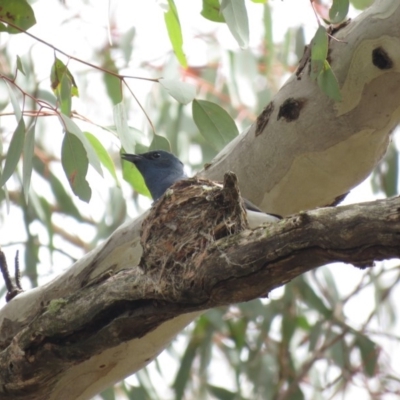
[0,180,400,399]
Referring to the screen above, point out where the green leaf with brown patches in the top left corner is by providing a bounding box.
[0,0,36,33]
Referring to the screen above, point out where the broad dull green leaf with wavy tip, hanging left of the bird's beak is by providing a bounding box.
[61,132,92,203]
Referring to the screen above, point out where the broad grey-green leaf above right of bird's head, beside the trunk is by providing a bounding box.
[192,100,239,150]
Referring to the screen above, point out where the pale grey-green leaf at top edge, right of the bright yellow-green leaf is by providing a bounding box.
[221,0,249,48]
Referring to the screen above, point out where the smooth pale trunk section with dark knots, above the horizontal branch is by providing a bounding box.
[204,0,400,215]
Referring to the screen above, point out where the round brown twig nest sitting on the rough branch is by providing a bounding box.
[141,172,248,284]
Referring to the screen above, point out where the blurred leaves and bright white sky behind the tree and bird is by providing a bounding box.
[0,0,400,400]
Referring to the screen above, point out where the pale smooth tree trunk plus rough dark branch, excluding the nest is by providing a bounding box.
[0,0,400,400]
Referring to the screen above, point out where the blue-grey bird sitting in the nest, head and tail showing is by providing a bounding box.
[121,150,282,225]
